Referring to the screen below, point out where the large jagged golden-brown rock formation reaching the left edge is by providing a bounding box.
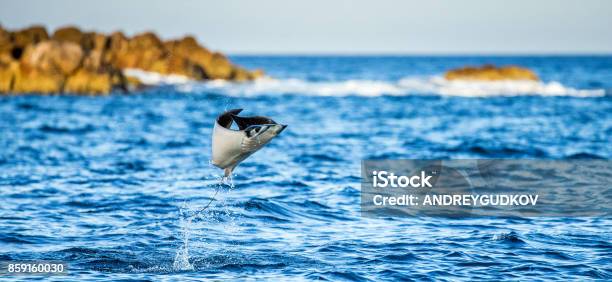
[0,26,263,94]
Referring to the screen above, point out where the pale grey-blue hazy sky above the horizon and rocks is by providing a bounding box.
[0,0,612,55]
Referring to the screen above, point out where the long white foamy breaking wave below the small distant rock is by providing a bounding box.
[176,76,606,97]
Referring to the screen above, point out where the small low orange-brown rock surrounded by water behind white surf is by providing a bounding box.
[444,65,539,81]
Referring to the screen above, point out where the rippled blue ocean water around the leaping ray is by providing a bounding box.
[0,56,612,281]
